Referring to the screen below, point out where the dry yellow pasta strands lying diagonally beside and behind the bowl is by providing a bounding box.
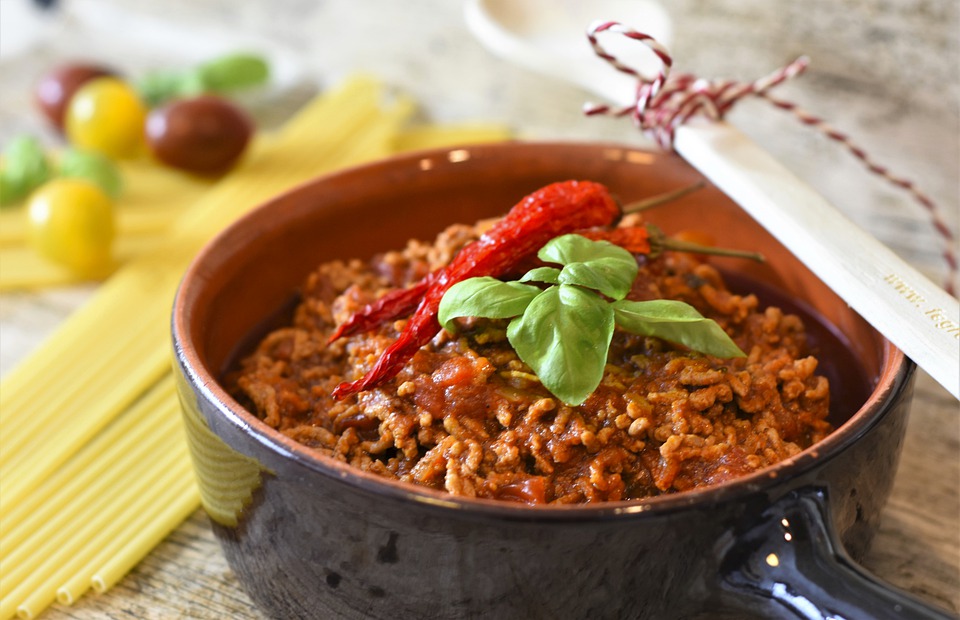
[0,77,507,620]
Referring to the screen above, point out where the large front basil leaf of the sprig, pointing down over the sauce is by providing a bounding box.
[507,284,614,405]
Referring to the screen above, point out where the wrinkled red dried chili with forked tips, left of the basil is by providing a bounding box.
[331,181,621,398]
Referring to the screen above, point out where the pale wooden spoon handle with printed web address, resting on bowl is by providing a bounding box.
[674,119,960,398]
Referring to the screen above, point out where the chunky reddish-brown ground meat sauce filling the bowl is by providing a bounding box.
[228,218,832,504]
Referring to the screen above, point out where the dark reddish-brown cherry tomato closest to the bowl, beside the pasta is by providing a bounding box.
[147,95,253,174]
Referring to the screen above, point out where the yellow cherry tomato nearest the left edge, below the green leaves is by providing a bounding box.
[27,178,115,277]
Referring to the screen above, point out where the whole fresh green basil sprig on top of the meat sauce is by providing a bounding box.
[438,235,744,405]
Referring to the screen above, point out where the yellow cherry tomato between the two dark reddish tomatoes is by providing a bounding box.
[66,77,147,159]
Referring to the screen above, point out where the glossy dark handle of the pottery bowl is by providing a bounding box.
[717,487,953,620]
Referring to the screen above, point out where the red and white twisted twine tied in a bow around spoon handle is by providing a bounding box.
[584,21,957,293]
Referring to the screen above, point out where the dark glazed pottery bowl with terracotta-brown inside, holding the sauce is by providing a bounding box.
[173,143,936,619]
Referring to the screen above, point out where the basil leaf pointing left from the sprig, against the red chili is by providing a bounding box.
[437,276,541,332]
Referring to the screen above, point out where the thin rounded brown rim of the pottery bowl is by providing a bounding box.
[171,141,915,521]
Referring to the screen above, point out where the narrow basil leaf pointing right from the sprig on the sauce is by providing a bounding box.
[612,299,745,358]
